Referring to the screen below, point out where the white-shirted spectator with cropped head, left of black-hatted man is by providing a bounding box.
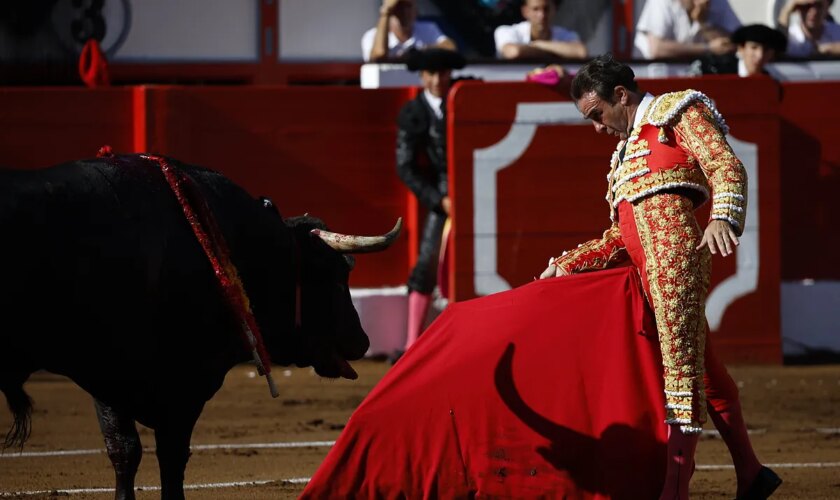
[633,0,741,59]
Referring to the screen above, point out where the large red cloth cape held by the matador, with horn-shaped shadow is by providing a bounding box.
[302,267,666,499]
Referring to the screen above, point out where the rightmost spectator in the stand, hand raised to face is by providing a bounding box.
[778,0,840,57]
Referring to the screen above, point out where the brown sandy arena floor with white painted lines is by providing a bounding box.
[0,361,840,499]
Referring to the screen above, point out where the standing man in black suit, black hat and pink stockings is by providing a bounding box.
[397,48,466,360]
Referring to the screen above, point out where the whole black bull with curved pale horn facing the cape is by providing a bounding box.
[0,155,399,498]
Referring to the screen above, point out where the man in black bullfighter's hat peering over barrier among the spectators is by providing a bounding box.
[695,24,787,77]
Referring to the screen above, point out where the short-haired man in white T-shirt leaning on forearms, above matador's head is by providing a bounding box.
[493,0,586,59]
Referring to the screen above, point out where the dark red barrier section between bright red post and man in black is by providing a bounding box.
[136,87,413,286]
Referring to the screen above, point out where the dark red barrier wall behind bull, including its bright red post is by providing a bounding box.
[0,86,416,286]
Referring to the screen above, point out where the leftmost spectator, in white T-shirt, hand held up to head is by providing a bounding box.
[362,0,456,62]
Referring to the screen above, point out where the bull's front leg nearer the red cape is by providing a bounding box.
[155,409,200,500]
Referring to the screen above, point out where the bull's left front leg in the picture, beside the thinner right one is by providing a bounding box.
[93,399,143,500]
